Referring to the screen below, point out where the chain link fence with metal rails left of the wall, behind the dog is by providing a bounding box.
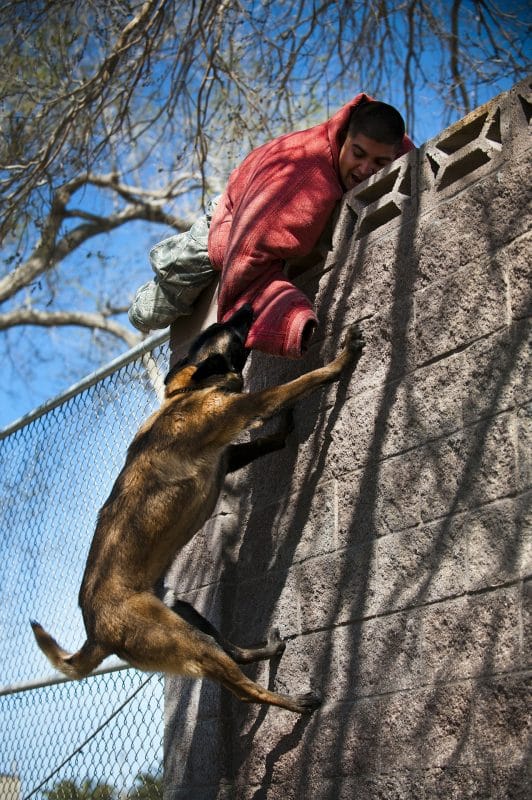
[0,336,168,800]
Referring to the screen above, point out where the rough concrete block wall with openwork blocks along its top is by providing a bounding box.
[165,81,532,800]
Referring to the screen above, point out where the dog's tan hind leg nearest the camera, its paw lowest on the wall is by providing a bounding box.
[122,593,321,714]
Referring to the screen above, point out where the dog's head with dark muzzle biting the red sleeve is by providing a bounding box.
[165,303,253,397]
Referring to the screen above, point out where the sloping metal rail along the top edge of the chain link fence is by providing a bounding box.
[0,329,170,441]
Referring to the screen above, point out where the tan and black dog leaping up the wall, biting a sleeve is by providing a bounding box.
[31,305,363,714]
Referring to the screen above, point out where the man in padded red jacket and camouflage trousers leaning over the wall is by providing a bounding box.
[129,94,414,358]
